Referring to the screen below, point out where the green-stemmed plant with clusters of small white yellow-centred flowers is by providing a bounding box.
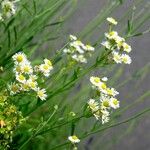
[0,0,150,150]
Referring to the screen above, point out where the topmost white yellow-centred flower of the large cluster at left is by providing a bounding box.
[12,52,27,64]
